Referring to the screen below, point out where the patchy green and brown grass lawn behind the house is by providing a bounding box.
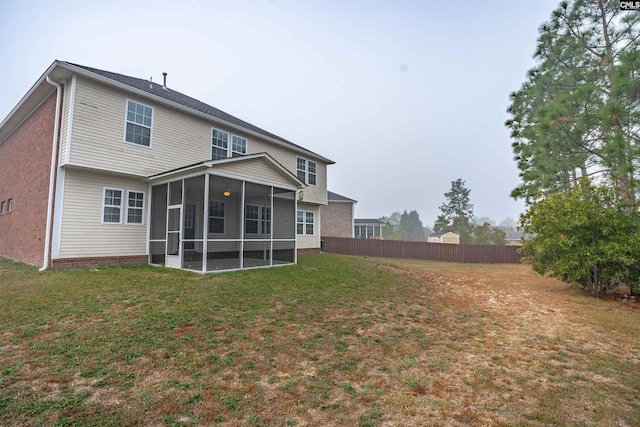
[0,254,640,426]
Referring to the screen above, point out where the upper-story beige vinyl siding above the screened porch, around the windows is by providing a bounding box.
[70,77,327,204]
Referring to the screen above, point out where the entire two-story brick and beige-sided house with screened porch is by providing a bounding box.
[0,61,333,272]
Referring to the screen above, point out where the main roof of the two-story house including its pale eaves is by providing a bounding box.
[0,60,335,164]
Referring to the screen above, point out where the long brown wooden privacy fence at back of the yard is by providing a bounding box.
[322,237,522,264]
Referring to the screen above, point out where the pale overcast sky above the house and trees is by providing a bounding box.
[0,0,558,226]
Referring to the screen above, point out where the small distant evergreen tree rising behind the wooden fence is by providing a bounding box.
[433,179,473,243]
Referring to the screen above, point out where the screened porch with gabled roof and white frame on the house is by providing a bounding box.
[149,154,304,273]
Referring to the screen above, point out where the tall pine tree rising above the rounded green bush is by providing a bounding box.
[506,0,640,205]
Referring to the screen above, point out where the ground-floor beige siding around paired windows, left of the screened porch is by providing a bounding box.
[60,169,149,258]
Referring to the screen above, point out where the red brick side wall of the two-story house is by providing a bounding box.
[0,92,56,265]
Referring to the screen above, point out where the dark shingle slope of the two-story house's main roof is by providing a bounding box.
[59,61,330,157]
